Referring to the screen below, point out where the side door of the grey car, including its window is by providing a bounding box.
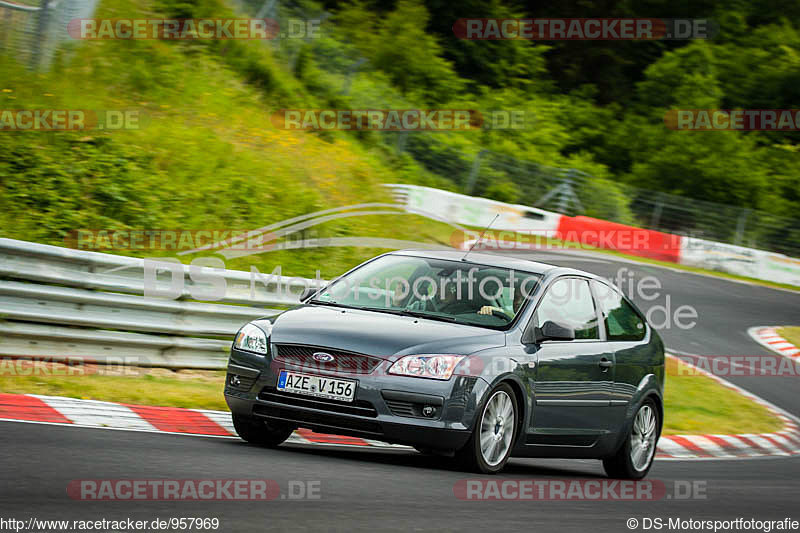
[529,277,614,440]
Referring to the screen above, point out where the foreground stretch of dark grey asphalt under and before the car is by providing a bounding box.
[0,422,800,532]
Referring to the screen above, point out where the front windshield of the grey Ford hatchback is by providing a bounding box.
[311,255,541,329]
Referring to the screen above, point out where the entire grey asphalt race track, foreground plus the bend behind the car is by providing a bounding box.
[0,253,800,532]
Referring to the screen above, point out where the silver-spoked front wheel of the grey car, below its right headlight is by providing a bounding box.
[456,383,519,474]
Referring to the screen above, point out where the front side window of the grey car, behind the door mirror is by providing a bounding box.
[534,278,600,339]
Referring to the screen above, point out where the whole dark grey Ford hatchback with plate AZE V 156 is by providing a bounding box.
[225,251,664,479]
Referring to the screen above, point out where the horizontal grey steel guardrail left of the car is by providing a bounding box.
[0,239,324,368]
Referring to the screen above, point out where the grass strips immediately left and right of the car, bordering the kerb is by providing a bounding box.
[0,359,782,435]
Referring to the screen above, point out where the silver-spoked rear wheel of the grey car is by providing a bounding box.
[603,398,661,479]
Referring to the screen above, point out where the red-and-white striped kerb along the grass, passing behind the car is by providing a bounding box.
[0,352,800,460]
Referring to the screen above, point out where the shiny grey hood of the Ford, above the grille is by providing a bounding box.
[256,305,505,360]
